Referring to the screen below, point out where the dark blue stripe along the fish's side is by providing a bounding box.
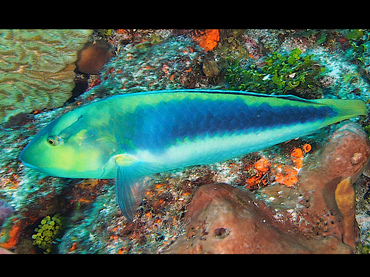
[124,99,337,154]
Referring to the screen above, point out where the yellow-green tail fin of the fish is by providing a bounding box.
[314,99,367,124]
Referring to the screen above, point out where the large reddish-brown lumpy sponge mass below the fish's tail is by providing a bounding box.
[167,123,370,253]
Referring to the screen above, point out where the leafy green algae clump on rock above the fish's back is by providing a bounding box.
[225,48,325,98]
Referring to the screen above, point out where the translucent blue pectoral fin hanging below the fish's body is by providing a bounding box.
[116,155,157,221]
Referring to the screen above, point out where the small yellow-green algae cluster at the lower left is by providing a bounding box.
[32,214,62,254]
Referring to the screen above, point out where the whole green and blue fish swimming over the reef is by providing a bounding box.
[19,89,367,220]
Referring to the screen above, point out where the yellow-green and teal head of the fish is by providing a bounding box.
[19,108,111,178]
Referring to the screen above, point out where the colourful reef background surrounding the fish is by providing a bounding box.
[0,29,370,254]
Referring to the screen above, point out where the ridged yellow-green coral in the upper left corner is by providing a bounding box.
[0,29,92,122]
